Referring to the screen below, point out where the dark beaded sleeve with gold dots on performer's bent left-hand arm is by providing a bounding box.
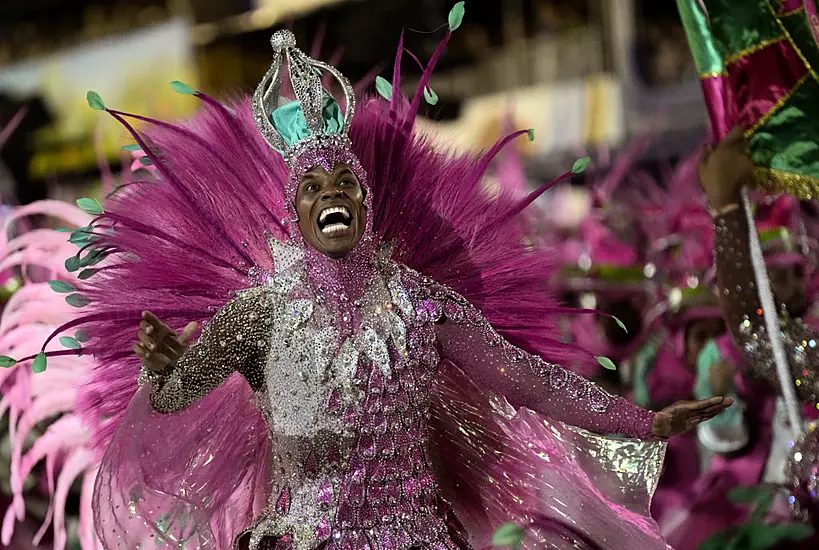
[145,289,270,412]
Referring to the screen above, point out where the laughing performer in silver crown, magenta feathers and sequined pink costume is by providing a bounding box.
[8,9,731,550]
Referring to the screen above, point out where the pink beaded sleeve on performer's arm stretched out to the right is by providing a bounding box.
[426,291,654,439]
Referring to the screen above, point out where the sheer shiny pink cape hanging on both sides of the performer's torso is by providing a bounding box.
[94,363,668,550]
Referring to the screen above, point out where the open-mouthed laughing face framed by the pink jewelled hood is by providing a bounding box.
[296,164,367,259]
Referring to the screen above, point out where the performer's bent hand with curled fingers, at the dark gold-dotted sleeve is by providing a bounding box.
[134,311,199,373]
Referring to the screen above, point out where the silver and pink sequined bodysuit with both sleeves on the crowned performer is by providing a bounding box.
[144,248,653,550]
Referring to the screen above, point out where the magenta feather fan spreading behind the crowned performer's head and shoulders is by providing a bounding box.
[49,50,583,462]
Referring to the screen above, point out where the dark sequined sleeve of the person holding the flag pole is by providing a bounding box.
[714,208,819,403]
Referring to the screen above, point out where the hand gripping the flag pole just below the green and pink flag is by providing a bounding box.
[698,127,754,210]
